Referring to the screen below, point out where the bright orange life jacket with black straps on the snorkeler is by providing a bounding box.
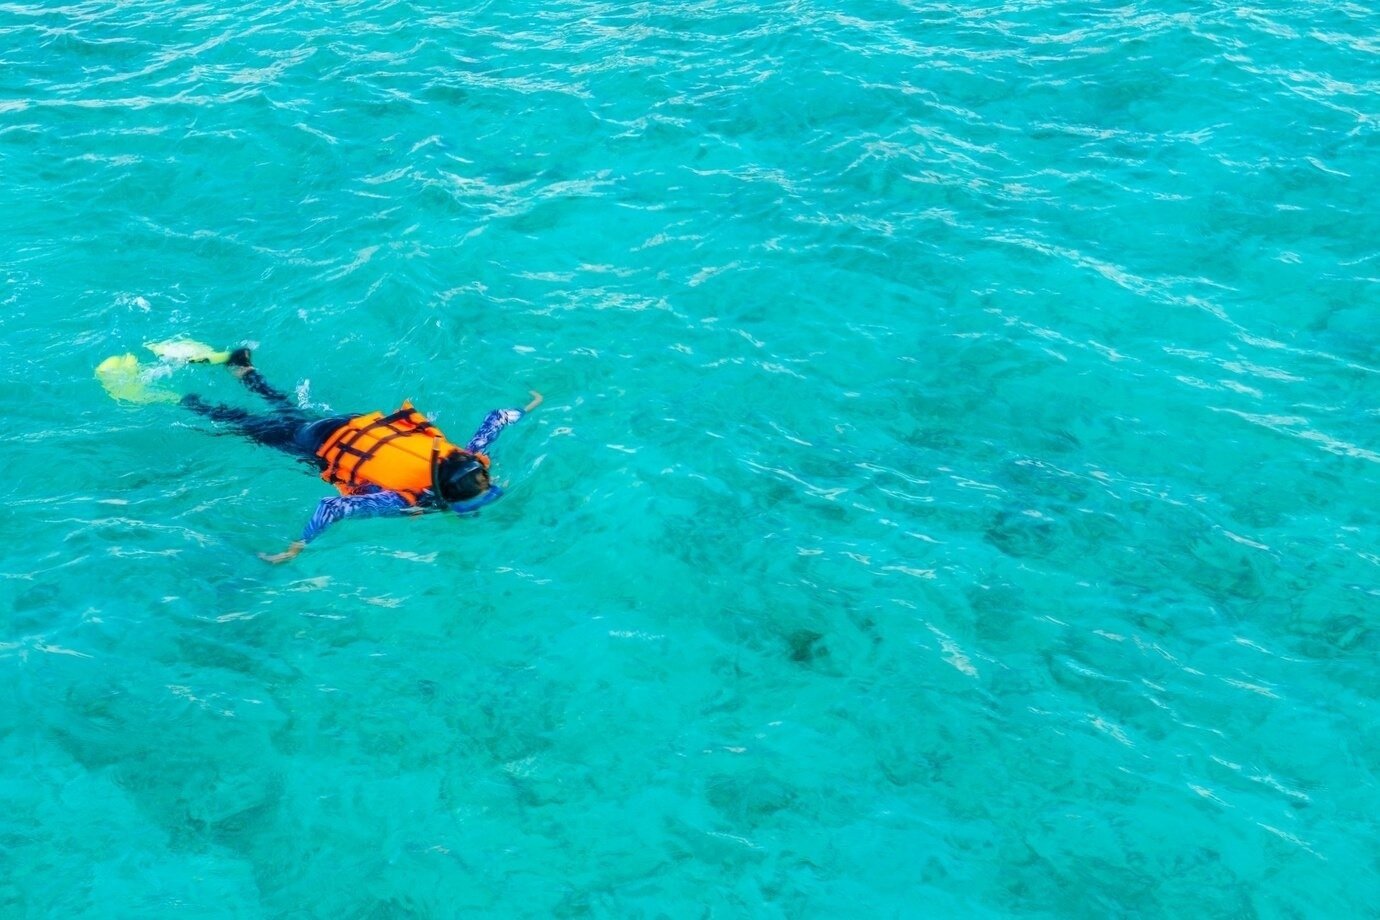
[316,401,489,505]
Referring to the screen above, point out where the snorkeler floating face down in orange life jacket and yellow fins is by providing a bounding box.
[97,341,541,563]
